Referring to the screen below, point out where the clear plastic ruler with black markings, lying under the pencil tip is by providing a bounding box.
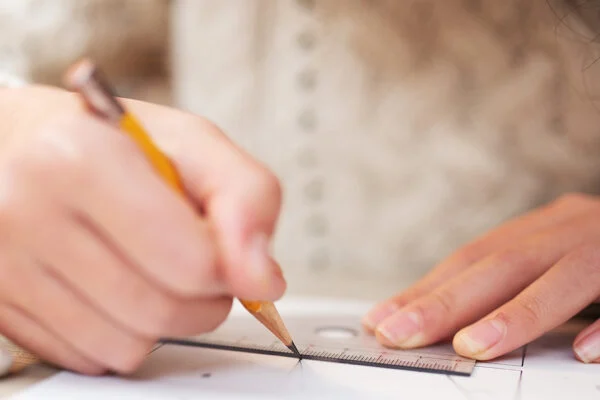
[163,316,475,376]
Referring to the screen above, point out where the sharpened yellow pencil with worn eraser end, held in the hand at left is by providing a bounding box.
[65,59,300,357]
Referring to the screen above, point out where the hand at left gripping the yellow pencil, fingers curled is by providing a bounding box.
[0,59,291,374]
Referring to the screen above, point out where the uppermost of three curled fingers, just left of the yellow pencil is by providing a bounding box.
[24,116,224,296]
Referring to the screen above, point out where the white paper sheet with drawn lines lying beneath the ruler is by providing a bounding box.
[7,296,600,400]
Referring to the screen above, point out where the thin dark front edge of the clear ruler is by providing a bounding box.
[161,338,475,377]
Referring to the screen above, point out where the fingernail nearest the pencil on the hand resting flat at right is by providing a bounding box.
[377,311,423,347]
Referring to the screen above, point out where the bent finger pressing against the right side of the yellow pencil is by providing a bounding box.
[178,126,286,300]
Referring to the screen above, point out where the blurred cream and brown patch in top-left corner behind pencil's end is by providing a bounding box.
[0,0,172,104]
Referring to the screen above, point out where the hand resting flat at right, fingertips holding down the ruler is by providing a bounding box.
[363,195,600,362]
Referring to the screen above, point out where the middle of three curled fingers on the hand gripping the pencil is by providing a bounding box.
[35,211,231,338]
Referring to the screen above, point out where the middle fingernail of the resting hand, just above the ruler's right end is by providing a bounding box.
[455,319,506,356]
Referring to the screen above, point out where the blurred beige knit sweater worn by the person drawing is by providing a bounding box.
[0,0,600,296]
